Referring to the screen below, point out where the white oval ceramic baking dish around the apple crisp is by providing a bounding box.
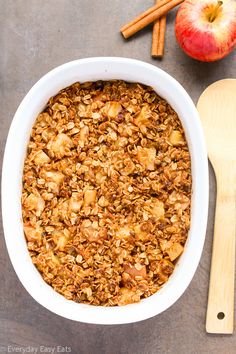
[2,58,208,324]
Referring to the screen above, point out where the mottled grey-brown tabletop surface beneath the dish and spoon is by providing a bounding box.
[0,0,236,354]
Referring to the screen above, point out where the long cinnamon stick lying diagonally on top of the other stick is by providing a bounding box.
[120,0,184,38]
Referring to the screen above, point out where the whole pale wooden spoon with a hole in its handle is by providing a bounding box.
[197,79,236,333]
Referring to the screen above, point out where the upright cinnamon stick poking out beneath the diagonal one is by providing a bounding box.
[151,0,166,58]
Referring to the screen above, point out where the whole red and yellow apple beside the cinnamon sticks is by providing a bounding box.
[175,0,236,61]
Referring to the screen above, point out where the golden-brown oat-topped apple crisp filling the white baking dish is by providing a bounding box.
[22,80,192,306]
